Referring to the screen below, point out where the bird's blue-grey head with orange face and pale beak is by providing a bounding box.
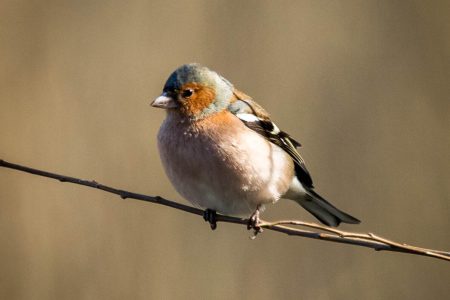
[152,64,233,120]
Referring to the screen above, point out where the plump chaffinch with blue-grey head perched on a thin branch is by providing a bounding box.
[151,63,360,230]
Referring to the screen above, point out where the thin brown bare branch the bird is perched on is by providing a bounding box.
[0,160,450,261]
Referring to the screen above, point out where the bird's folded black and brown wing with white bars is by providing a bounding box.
[228,89,313,188]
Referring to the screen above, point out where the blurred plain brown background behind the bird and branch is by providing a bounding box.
[0,0,450,299]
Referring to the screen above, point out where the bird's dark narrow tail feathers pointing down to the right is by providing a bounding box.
[295,189,361,227]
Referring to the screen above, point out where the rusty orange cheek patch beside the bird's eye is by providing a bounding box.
[181,83,216,115]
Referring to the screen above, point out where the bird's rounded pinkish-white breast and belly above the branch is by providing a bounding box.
[158,112,294,216]
